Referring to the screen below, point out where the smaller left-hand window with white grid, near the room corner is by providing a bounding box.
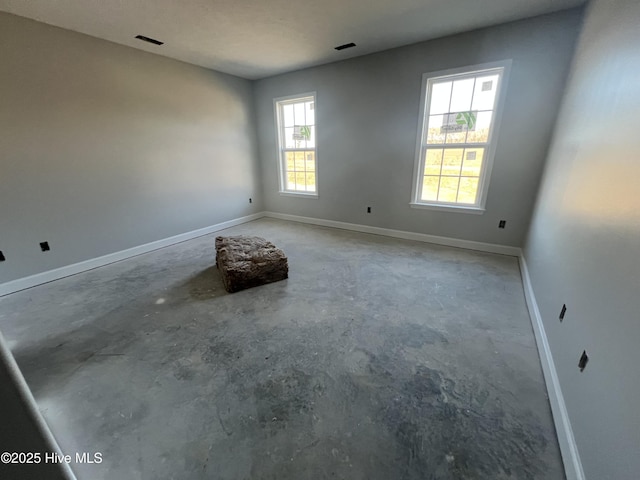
[274,93,318,196]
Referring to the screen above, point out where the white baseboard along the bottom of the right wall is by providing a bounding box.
[520,255,585,480]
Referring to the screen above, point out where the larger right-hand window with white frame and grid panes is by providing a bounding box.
[412,61,510,212]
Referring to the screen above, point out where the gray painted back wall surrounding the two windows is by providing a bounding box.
[254,10,582,246]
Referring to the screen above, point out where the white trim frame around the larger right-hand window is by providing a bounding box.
[409,59,512,215]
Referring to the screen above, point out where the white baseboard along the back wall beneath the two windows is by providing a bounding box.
[264,212,520,257]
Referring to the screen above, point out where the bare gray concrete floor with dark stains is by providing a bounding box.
[0,219,564,480]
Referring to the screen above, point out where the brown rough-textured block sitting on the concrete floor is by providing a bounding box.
[216,236,289,293]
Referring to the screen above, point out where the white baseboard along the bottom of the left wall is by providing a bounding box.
[0,212,264,297]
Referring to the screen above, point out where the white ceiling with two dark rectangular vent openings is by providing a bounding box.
[0,0,584,79]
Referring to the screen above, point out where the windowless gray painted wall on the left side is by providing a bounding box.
[0,13,263,283]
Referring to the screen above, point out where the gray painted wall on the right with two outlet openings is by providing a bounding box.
[525,0,640,480]
